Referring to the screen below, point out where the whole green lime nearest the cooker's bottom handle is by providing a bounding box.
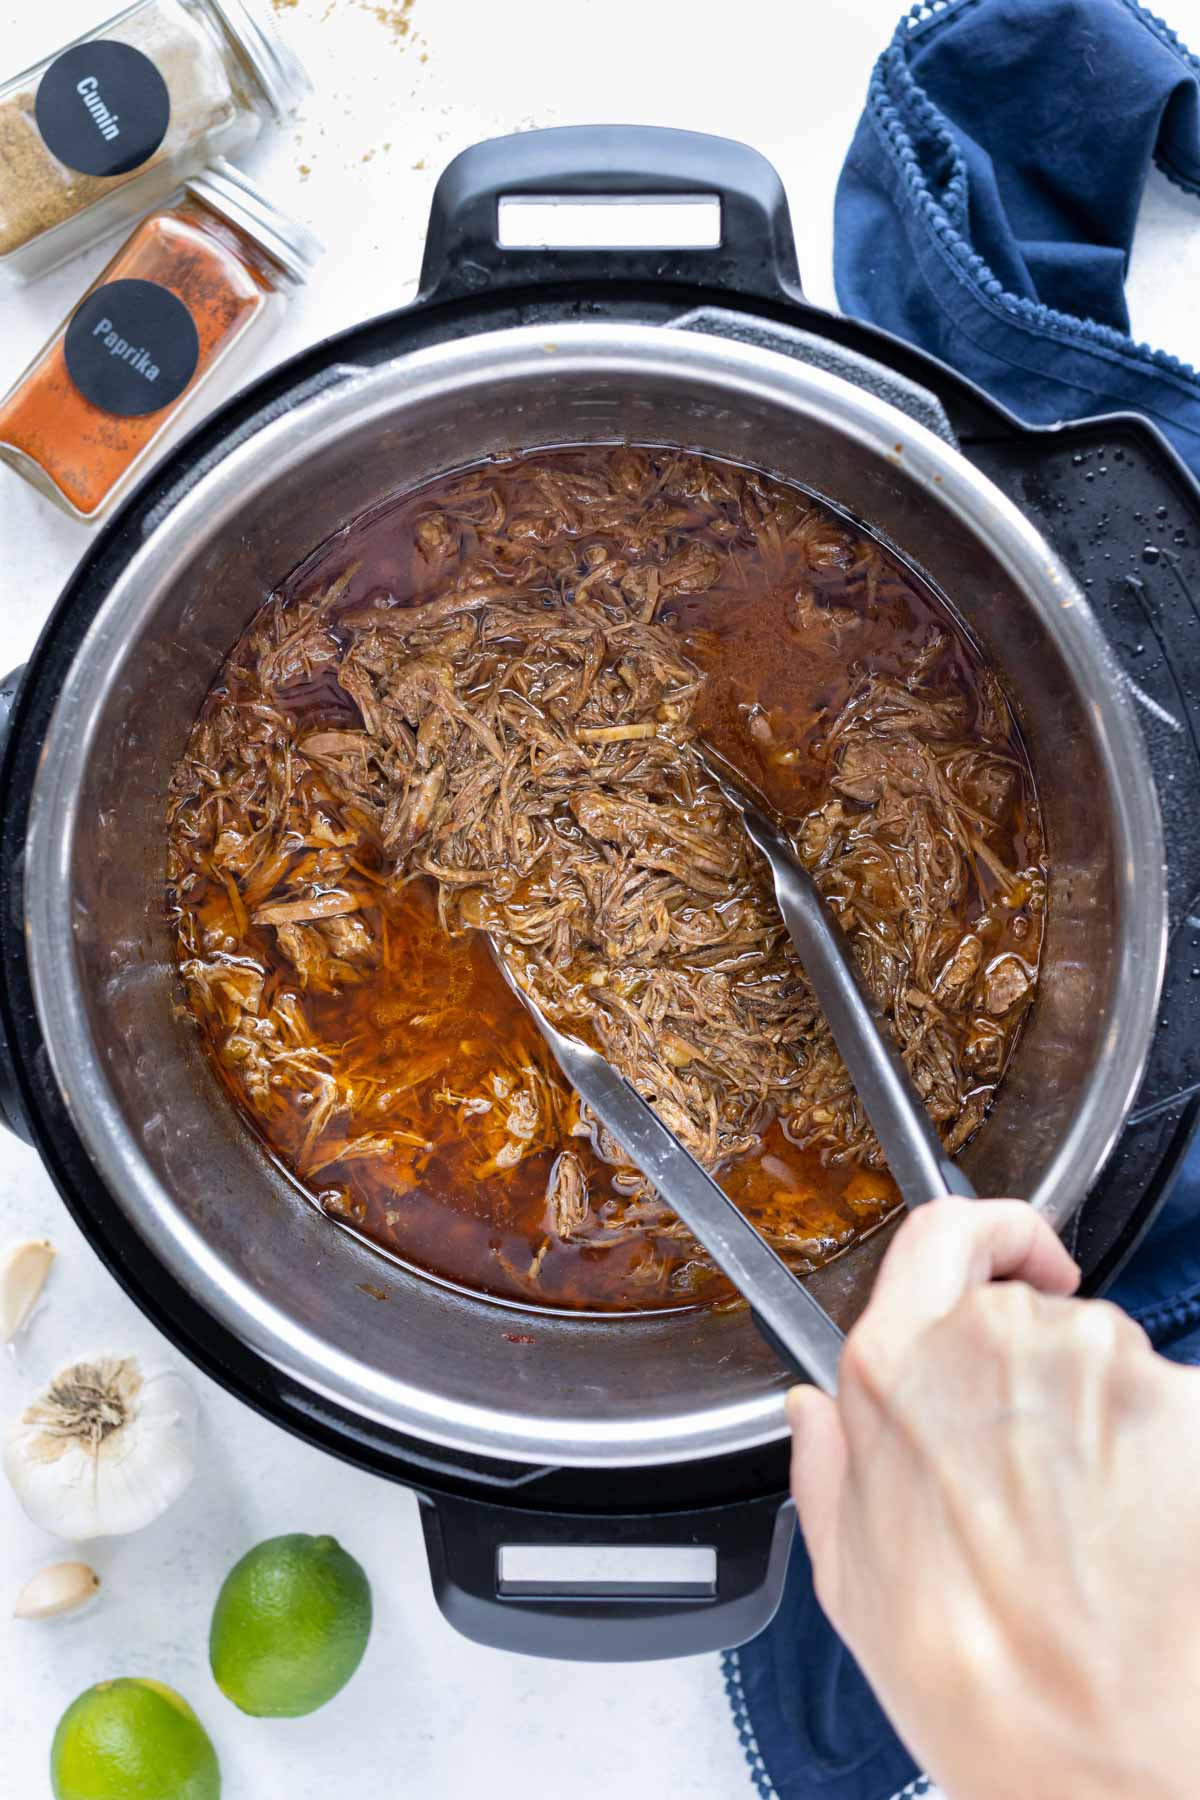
[209,1532,371,1719]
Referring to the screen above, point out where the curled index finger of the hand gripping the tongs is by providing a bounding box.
[860,1195,1079,1352]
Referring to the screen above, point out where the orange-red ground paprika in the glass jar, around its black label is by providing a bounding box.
[0,198,275,518]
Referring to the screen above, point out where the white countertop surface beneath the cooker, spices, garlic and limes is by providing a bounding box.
[0,0,1200,1800]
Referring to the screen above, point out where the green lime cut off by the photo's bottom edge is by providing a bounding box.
[50,1676,221,1800]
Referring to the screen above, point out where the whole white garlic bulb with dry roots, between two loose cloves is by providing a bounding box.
[4,1355,196,1537]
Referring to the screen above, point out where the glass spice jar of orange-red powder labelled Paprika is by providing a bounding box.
[0,160,320,518]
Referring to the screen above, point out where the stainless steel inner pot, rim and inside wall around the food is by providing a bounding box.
[27,324,1166,1465]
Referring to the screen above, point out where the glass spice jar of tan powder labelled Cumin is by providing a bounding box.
[0,0,309,281]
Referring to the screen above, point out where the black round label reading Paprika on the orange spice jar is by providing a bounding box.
[63,281,200,418]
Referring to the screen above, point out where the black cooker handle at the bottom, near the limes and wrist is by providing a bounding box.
[421,1494,793,1663]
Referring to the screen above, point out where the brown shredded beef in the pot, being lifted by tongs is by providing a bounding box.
[171,450,1042,1287]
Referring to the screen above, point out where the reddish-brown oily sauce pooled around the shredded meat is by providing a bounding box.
[171,448,1042,1312]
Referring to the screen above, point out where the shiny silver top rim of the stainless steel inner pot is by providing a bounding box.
[25,322,1168,1467]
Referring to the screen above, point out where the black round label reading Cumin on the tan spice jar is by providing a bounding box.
[34,38,171,175]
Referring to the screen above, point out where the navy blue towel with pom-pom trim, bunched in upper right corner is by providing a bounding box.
[833,0,1200,473]
